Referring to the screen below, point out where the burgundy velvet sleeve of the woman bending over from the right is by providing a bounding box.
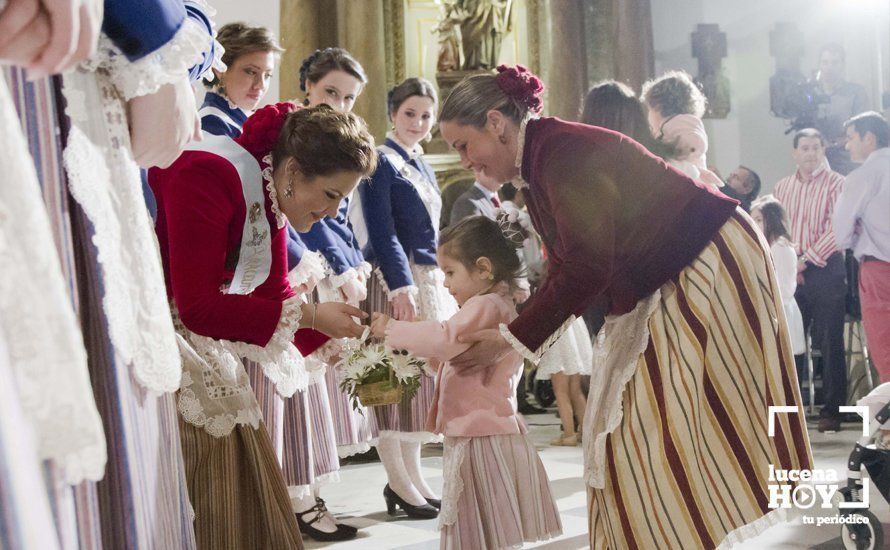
[508,141,617,354]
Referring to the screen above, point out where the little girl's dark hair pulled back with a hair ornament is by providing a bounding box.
[439,212,526,288]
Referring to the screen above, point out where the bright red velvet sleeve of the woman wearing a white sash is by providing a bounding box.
[152,153,282,346]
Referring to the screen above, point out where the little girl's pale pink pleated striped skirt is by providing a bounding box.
[439,434,562,550]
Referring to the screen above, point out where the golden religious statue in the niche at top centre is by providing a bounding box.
[435,0,513,72]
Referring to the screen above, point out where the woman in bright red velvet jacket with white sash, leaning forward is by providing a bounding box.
[149,103,377,550]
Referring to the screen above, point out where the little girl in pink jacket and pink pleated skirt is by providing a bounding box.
[371,215,562,549]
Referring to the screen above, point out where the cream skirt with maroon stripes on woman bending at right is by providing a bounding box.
[584,211,812,549]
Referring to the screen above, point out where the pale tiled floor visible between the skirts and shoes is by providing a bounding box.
[306,414,890,550]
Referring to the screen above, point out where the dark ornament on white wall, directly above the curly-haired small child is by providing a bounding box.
[692,24,730,118]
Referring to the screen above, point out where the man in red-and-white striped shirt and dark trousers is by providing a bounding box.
[775,128,847,432]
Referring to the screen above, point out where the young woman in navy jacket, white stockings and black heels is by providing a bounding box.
[350,78,457,517]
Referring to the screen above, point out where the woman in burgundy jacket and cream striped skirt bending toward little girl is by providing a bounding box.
[440,66,812,548]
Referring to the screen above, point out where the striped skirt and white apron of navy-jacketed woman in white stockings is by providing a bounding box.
[365,264,457,444]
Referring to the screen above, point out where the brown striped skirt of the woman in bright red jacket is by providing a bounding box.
[179,417,303,550]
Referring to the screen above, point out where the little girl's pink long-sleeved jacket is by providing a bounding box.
[386,293,528,437]
